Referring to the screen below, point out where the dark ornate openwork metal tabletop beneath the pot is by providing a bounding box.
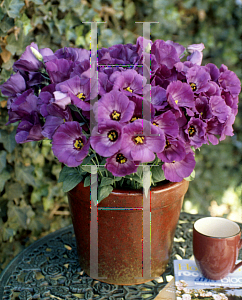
[0,213,242,300]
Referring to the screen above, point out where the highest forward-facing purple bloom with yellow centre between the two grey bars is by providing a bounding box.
[110,70,146,96]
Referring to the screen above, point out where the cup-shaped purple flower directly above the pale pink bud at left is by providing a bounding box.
[45,58,73,83]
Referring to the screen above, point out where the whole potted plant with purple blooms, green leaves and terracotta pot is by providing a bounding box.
[1,37,241,284]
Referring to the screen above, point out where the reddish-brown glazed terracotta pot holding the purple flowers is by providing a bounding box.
[68,180,189,285]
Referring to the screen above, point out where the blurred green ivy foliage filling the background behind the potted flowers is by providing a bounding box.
[0,0,242,269]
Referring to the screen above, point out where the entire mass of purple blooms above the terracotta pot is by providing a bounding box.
[0,37,241,182]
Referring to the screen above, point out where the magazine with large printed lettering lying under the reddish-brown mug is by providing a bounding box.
[174,259,242,300]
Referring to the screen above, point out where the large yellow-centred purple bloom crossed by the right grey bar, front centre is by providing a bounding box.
[120,120,166,162]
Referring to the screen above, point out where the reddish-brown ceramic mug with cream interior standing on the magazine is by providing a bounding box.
[193,217,242,280]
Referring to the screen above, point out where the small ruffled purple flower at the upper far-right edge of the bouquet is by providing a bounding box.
[218,70,241,97]
